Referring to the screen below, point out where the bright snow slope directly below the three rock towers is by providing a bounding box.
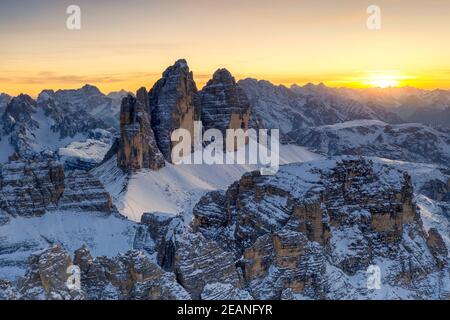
[92,145,320,221]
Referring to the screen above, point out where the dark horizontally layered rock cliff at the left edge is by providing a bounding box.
[0,160,117,218]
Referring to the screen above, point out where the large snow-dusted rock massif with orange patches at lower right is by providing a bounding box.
[193,157,448,299]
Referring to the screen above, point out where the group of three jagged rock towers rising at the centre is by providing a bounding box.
[112,60,255,171]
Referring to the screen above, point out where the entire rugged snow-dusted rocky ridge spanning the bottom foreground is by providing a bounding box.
[0,157,450,300]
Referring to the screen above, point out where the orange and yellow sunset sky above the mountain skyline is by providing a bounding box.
[0,0,450,96]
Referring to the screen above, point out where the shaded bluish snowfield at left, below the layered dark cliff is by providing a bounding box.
[0,211,136,280]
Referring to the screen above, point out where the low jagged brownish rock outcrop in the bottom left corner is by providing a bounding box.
[11,245,190,300]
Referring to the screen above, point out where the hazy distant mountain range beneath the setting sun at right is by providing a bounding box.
[239,79,450,134]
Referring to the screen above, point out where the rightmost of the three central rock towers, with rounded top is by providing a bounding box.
[200,69,250,139]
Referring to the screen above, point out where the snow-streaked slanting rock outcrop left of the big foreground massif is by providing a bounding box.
[134,213,251,300]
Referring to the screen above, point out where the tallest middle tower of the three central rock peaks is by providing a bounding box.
[149,60,200,162]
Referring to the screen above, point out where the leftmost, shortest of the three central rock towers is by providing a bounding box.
[117,88,165,171]
